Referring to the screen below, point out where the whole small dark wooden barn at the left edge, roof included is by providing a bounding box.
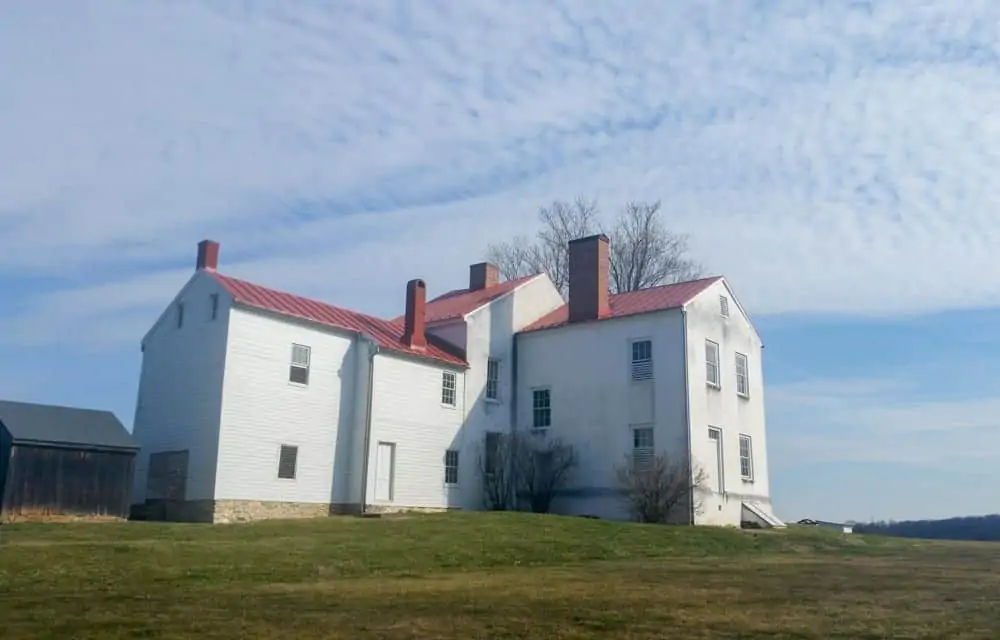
[0,401,139,520]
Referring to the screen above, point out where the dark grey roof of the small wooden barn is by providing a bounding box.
[0,400,139,450]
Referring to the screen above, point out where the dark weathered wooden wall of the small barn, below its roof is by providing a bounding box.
[2,444,135,518]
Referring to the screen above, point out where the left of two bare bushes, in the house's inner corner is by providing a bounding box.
[480,431,577,513]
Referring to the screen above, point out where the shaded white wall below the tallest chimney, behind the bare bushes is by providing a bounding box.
[516,309,687,518]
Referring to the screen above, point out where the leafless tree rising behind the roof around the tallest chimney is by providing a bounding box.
[487,198,701,296]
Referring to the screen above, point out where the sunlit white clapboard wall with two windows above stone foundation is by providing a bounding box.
[215,307,367,504]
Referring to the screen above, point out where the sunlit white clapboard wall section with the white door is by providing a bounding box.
[366,351,466,509]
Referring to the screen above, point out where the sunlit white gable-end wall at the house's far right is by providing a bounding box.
[687,282,770,526]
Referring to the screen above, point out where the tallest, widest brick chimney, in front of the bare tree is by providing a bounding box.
[569,233,611,322]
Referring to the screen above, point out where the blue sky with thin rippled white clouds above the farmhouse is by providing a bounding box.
[0,0,1000,519]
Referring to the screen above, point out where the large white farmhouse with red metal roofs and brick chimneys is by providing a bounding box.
[133,236,781,526]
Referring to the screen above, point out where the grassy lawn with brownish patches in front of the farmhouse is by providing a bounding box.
[0,513,1000,640]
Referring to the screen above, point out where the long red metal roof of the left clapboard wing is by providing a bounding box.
[210,272,467,366]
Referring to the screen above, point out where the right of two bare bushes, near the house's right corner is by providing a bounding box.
[615,453,708,523]
